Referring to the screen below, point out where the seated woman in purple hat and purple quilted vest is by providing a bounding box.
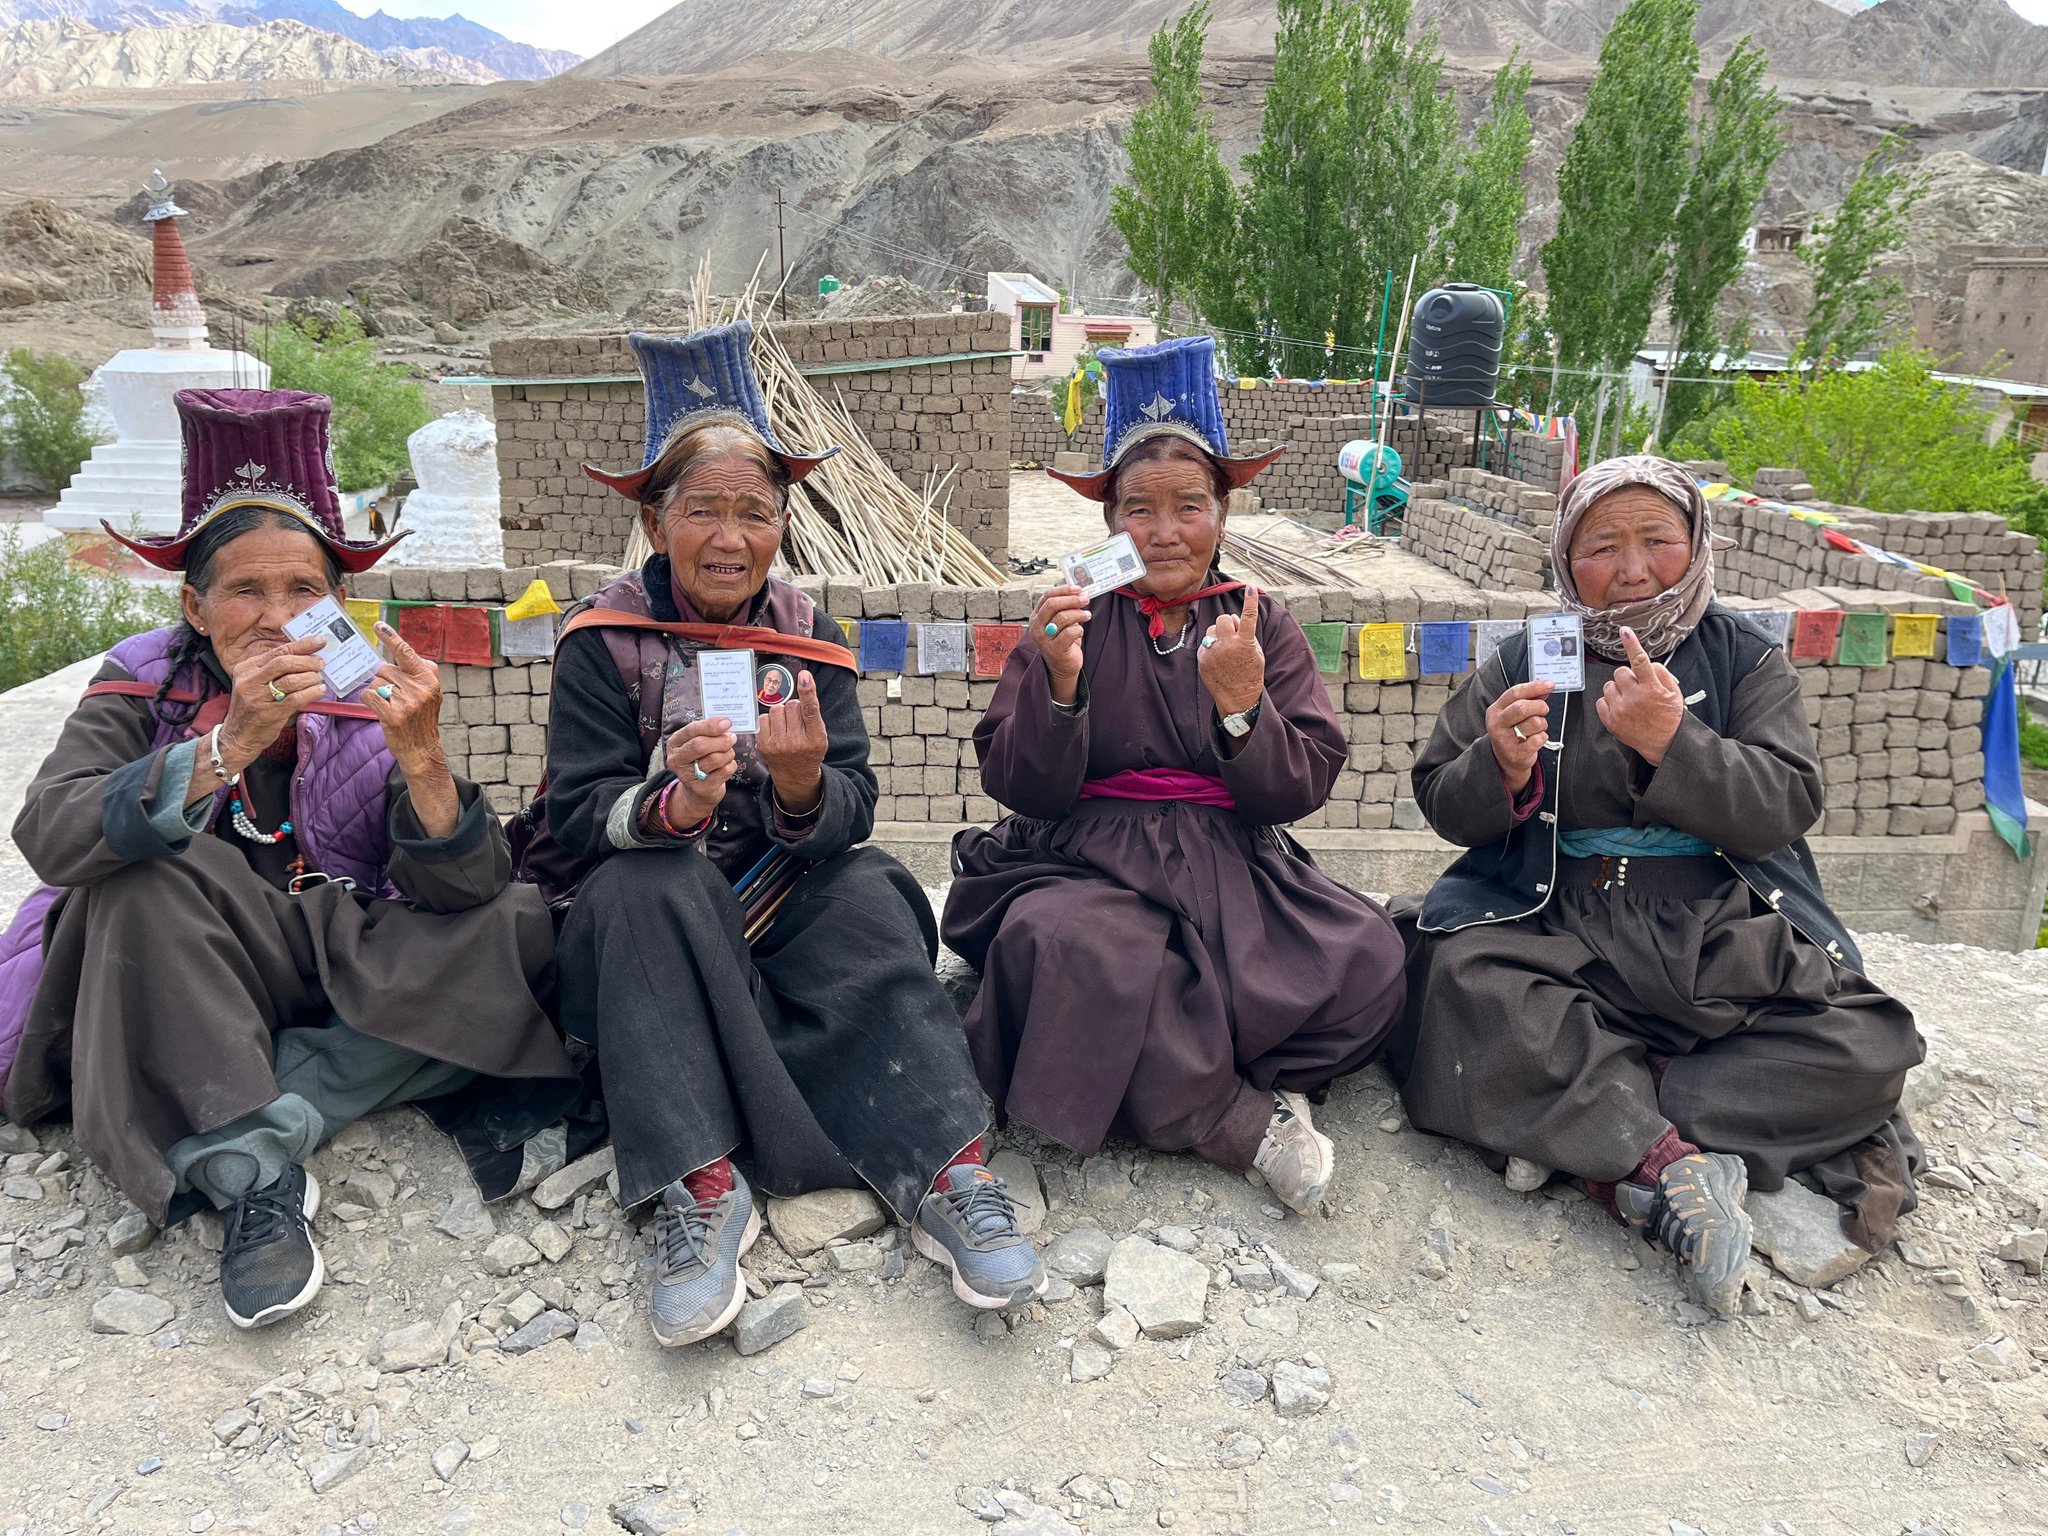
[0,389,575,1327]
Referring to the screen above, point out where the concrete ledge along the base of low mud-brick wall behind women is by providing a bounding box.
[872,803,2048,950]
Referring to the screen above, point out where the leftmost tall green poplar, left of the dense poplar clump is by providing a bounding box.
[1110,0,1235,326]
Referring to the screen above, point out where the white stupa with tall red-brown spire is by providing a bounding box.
[43,170,270,535]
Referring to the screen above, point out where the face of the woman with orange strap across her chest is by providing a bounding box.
[641,451,782,625]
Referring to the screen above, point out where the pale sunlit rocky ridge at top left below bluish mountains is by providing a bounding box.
[0,20,492,96]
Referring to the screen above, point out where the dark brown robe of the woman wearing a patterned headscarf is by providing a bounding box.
[1389,649,1923,1245]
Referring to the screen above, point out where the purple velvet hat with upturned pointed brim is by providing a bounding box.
[100,389,406,571]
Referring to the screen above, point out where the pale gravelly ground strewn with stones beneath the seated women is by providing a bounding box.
[0,668,2048,1536]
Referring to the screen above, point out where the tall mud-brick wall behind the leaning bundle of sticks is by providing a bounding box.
[492,313,1010,563]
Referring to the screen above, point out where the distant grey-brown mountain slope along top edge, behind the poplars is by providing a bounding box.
[580,0,2048,86]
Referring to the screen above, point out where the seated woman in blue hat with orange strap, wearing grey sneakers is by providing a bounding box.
[547,322,1044,1346]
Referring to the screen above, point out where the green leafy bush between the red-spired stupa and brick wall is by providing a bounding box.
[256,311,434,492]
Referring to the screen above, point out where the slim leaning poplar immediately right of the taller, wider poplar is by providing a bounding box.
[1659,37,1784,436]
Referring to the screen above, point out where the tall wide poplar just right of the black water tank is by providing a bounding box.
[1542,0,1700,444]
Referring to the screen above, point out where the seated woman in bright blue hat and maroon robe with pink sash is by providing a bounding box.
[944,336,1403,1212]
